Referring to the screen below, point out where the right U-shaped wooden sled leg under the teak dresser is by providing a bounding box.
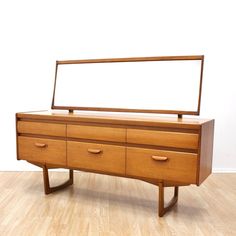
[158,183,179,217]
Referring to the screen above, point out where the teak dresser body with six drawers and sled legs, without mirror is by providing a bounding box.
[16,54,214,216]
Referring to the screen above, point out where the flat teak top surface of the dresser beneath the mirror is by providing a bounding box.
[17,110,210,129]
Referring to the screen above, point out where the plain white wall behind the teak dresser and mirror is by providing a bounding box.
[0,0,236,171]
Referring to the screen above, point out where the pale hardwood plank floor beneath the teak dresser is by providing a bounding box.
[0,172,236,236]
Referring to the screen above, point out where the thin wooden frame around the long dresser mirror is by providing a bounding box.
[51,55,204,118]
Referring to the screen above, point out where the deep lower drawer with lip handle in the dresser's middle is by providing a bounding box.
[67,141,125,174]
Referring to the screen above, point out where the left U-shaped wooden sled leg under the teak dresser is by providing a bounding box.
[42,165,74,194]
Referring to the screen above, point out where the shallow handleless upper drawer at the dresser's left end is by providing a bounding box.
[17,121,66,137]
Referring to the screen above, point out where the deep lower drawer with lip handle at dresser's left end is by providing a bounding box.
[18,136,66,165]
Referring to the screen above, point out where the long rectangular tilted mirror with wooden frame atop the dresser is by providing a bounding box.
[52,56,204,115]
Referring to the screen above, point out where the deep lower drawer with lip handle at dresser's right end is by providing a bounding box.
[126,147,197,183]
